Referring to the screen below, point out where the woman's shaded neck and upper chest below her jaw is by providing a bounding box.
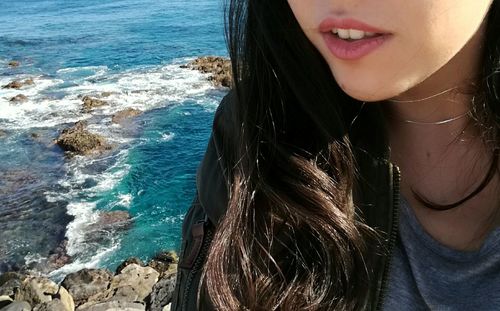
[381,19,500,249]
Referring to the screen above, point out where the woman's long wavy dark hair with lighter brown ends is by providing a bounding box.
[200,0,500,310]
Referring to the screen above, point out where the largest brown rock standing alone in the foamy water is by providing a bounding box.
[55,121,111,155]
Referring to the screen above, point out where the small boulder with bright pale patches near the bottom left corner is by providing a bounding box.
[14,277,59,306]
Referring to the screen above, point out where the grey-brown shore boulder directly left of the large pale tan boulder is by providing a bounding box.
[61,269,113,306]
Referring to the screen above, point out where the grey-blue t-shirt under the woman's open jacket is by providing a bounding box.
[383,198,500,311]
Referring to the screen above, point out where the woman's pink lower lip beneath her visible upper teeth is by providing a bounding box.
[323,32,391,60]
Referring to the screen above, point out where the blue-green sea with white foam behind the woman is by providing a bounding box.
[0,0,228,279]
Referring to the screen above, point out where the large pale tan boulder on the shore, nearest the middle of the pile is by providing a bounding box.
[106,264,160,302]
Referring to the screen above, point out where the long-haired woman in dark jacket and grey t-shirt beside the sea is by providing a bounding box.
[172,0,500,310]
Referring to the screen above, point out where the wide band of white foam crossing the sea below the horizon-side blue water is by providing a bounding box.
[0,58,224,133]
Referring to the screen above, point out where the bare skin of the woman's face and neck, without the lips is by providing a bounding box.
[288,0,500,250]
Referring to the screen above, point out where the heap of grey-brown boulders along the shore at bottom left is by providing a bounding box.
[0,251,178,311]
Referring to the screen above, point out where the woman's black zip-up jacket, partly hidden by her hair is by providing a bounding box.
[171,92,400,311]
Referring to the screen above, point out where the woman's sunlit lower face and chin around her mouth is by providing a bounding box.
[288,0,492,101]
